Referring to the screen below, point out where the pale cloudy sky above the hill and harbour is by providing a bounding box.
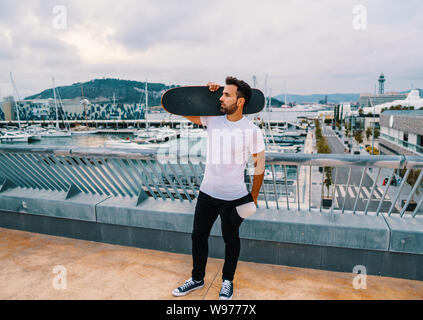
[0,0,423,96]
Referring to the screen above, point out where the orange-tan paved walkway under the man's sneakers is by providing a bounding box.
[0,228,423,301]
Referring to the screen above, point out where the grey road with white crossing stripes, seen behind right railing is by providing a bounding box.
[322,126,397,212]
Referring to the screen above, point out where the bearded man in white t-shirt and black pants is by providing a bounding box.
[172,77,265,300]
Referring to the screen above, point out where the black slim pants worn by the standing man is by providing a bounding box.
[191,191,254,281]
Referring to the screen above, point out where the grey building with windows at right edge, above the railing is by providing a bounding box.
[379,110,423,155]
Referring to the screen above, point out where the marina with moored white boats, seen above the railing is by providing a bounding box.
[0,111,317,153]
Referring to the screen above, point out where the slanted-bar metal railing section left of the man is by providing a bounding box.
[0,146,204,201]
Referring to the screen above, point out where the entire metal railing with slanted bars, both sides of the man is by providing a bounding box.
[0,146,423,217]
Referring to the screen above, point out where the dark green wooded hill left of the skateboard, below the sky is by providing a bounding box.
[25,79,176,106]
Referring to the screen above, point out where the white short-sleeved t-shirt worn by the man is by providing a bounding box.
[200,115,265,200]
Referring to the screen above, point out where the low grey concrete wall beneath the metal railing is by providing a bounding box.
[0,188,423,280]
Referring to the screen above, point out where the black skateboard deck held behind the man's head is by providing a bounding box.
[162,86,265,116]
